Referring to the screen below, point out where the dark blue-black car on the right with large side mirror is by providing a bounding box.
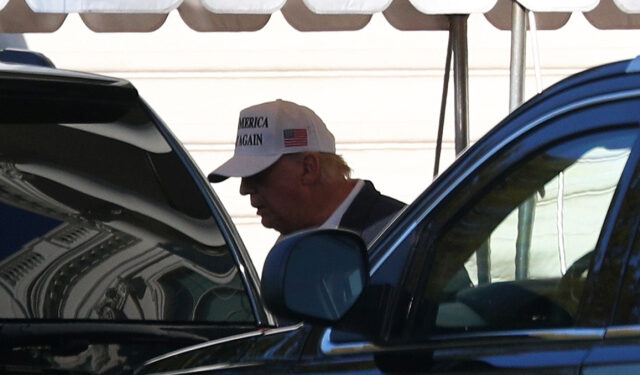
[135,58,640,375]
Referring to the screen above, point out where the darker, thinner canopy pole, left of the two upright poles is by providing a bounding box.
[449,14,469,155]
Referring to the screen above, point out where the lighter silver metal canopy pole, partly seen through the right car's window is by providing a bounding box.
[509,1,536,280]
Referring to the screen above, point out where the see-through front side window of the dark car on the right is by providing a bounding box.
[408,131,635,339]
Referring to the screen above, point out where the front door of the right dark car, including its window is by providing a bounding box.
[304,86,640,374]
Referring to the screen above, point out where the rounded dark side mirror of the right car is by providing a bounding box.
[262,229,369,324]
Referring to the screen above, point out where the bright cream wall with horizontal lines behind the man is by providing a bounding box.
[17,12,640,269]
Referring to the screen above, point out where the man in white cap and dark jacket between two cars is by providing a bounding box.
[209,99,404,243]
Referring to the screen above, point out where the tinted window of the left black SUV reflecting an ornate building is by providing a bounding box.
[0,104,255,322]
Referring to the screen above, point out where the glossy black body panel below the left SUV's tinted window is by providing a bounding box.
[0,321,260,375]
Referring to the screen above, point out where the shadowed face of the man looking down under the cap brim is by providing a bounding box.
[240,154,305,234]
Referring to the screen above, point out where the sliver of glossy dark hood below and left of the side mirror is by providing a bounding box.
[134,323,311,375]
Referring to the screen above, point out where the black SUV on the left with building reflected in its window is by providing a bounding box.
[0,51,274,374]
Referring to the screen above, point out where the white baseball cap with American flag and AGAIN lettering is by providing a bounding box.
[208,99,336,182]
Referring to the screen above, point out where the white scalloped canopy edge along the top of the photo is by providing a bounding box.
[0,0,640,33]
